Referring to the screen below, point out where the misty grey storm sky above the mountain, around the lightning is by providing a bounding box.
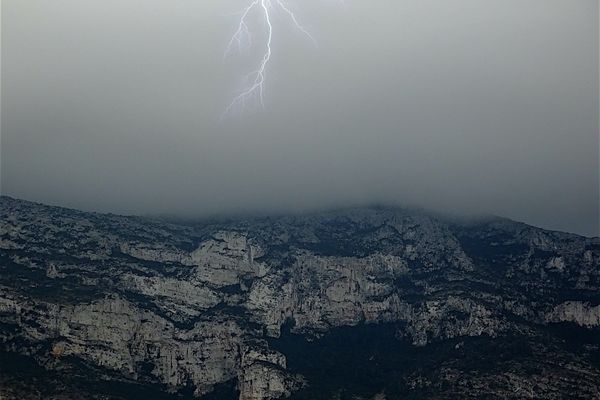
[1,0,599,235]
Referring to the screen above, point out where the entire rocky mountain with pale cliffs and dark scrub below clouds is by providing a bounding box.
[0,197,600,400]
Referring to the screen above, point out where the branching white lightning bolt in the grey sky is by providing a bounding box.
[222,0,316,118]
